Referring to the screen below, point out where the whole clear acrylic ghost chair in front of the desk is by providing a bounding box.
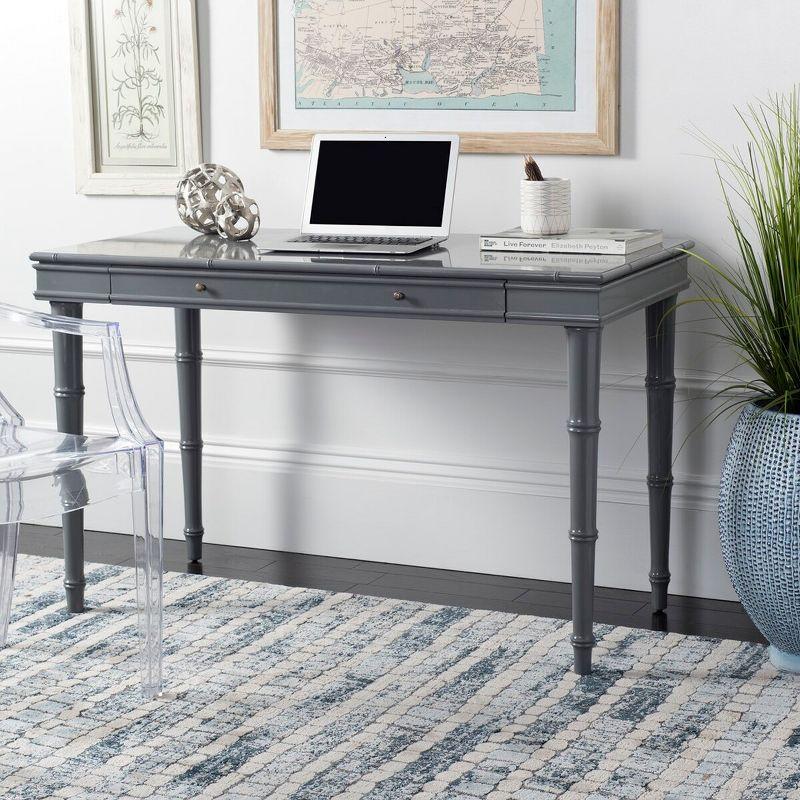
[0,304,164,698]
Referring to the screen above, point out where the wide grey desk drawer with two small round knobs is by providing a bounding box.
[111,267,505,321]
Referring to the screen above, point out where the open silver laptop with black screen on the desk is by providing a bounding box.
[259,133,458,255]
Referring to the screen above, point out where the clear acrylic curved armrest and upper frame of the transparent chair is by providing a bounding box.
[0,303,159,444]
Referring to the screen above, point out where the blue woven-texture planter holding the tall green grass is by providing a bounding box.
[719,404,800,656]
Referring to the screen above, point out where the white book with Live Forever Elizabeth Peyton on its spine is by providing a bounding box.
[480,228,664,256]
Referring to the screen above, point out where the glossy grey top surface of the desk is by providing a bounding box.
[31,226,694,284]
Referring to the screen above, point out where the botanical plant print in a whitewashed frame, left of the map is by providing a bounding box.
[69,0,202,195]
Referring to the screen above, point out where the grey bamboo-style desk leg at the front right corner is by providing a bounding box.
[566,327,601,675]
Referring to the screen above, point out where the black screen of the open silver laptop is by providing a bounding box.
[309,139,451,228]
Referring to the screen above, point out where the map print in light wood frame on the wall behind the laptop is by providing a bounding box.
[259,0,619,155]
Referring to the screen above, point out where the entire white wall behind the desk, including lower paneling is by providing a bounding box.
[0,0,800,597]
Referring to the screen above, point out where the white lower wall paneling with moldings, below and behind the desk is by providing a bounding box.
[0,337,733,598]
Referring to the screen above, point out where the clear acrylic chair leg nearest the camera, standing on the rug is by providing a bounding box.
[132,445,164,699]
